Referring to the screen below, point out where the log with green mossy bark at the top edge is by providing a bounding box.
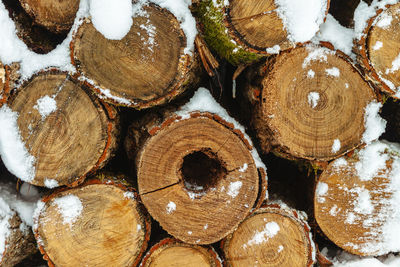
[194,0,329,65]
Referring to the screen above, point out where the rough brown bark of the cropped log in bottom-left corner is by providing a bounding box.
[0,215,37,267]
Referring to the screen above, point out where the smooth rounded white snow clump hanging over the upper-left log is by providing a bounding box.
[89,0,133,40]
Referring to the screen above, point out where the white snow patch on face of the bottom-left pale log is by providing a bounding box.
[54,194,83,226]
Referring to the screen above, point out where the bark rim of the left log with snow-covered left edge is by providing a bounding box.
[8,68,120,188]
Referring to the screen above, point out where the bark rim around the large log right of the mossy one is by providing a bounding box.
[243,42,382,163]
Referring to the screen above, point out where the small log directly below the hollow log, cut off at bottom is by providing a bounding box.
[140,238,222,267]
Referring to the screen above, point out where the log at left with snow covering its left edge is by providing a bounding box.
[9,70,118,188]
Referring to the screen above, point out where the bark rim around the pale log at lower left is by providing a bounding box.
[33,177,151,267]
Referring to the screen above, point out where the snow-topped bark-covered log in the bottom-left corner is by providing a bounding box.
[0,197,37,267]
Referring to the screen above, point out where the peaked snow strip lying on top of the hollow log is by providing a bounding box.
[175,87,267,170]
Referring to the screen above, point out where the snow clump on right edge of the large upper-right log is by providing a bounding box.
[362,100,386,144]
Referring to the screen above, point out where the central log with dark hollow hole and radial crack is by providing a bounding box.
[125,112,265,244]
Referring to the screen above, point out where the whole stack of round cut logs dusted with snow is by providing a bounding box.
[0,0,400,266]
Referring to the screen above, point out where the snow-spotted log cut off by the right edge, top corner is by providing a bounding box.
[355,3,400,99]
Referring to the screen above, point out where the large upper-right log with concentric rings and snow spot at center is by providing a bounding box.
[238,45,376,161]
